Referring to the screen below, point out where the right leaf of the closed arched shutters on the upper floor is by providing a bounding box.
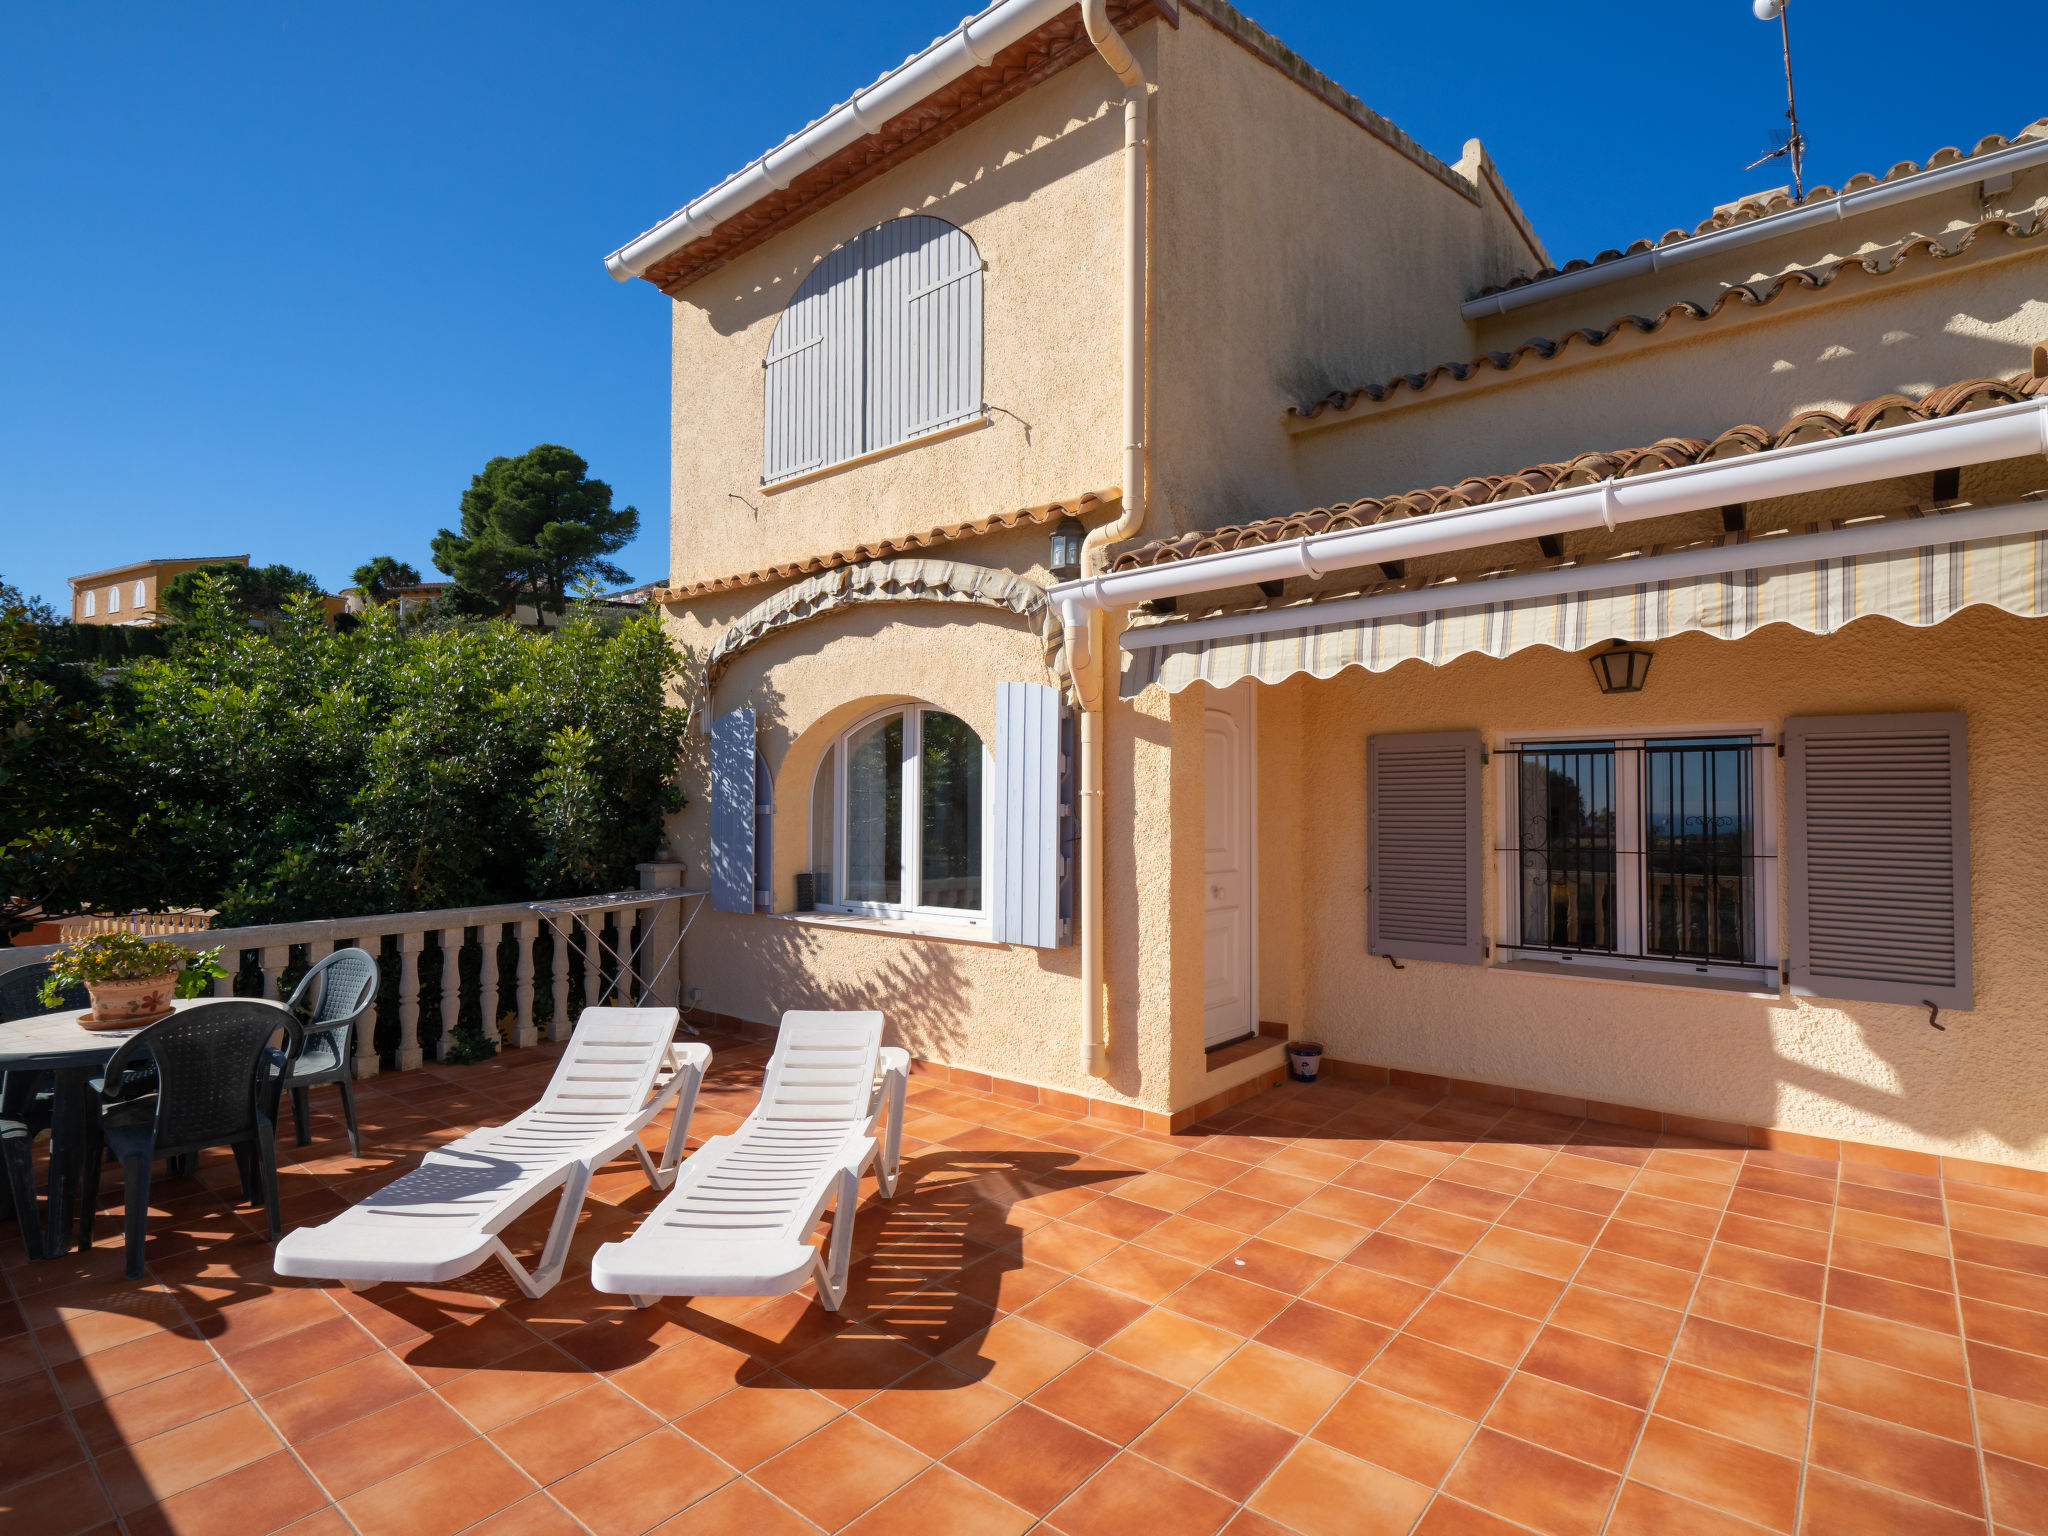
[862,213,981,451]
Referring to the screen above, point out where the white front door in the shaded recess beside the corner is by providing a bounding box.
[1202,682,1257,1044]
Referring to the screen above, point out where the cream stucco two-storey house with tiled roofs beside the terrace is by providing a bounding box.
[608,0,2048,1182]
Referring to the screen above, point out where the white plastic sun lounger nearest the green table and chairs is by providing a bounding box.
[272,1008,711,1296]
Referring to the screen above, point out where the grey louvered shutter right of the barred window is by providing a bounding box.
[1786,715,1972,1008]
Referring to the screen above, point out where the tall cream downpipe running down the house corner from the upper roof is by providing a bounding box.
[1065,0,1149,1077]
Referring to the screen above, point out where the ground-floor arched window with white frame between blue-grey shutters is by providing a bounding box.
[811,705,993,920]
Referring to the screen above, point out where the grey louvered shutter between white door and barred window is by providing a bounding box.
[1366,731,1485,965]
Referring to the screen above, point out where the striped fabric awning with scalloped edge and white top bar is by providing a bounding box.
[1120,502,2048,698]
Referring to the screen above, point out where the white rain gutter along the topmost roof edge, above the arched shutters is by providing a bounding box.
[604,0,1073,283]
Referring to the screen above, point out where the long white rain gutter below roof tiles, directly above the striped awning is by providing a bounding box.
[1047,397,2048,635]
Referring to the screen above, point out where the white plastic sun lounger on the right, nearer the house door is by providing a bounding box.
[590,1014,909,1311]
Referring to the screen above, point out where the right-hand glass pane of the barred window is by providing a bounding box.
[1642,741,1753,961]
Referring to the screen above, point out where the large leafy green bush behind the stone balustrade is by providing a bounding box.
[0,578,686,926]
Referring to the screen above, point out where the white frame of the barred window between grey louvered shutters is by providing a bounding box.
[1493,721,1784,991]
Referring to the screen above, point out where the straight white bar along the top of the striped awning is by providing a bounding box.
[1122,500,2048,651]
